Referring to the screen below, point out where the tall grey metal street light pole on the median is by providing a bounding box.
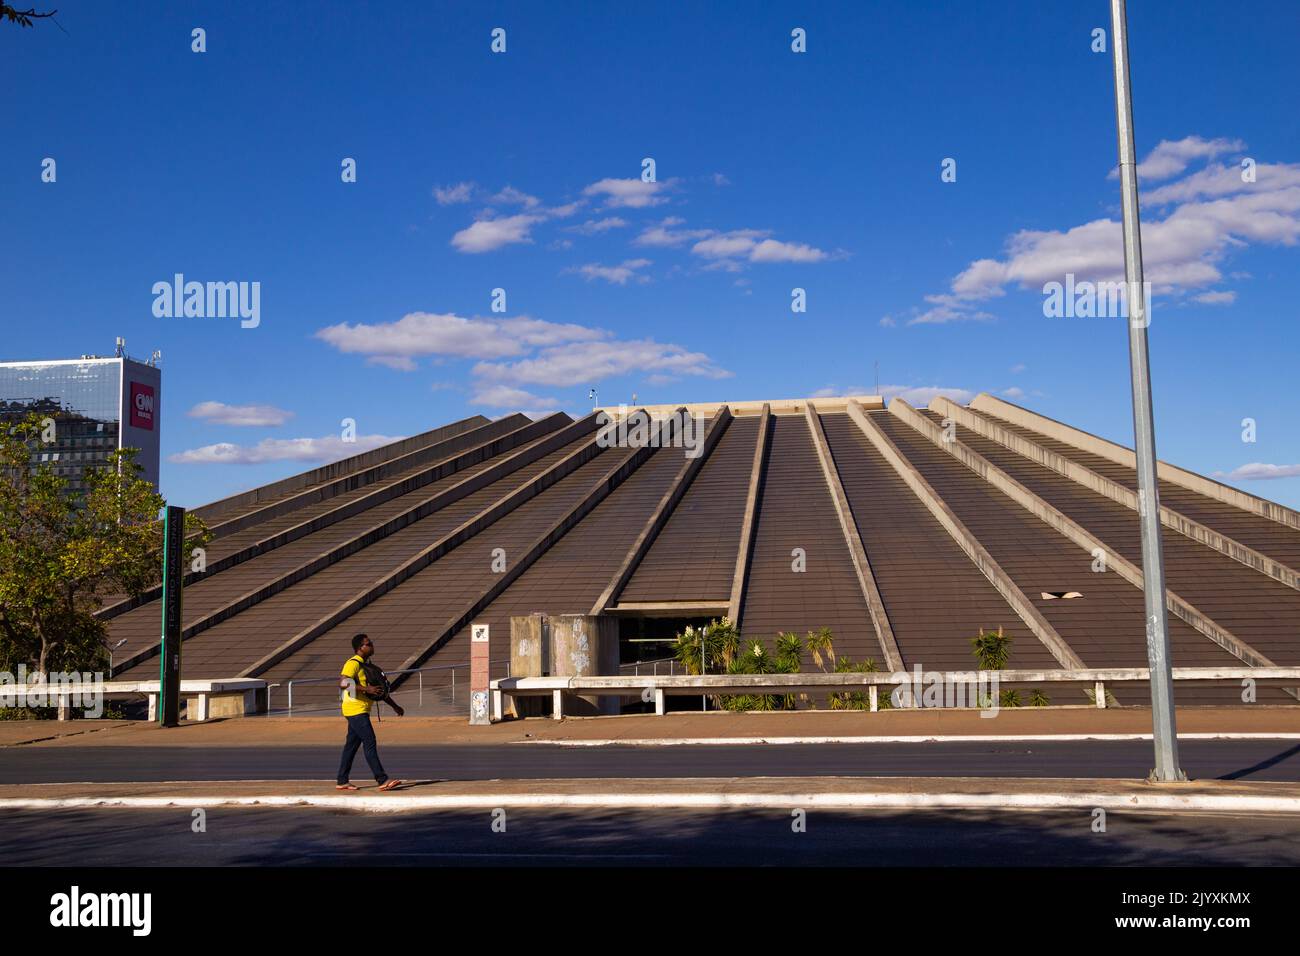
[1110,0,1187,782]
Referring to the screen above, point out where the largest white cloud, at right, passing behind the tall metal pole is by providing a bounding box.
[909,137,1300,325]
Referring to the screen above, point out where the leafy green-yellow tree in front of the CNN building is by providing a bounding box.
[0,415,212,674]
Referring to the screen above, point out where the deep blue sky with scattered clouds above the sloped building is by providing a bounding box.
[0,0,1300,506]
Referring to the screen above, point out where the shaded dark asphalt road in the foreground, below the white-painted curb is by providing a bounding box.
[0,808,1300,868]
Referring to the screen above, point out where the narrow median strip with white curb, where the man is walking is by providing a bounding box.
[0,777,1300,814]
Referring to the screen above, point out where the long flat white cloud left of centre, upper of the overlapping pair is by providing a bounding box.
[316,312,608,371]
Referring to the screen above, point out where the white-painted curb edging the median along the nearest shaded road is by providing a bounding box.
[0,791,1300,814]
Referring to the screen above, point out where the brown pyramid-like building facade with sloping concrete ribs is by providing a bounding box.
[103,395,1300,702]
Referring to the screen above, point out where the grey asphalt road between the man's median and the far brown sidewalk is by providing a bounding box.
[0,740,1300,783]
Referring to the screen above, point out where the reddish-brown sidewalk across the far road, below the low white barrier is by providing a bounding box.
[0,704,1300,747]
